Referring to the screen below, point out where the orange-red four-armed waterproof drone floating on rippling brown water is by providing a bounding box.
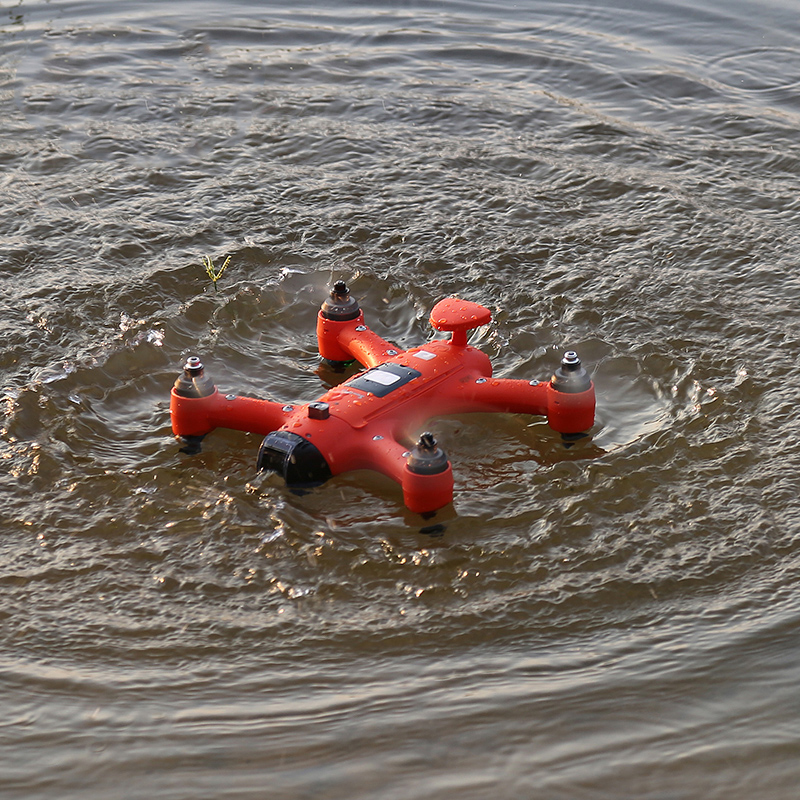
[170,281,595,514]
